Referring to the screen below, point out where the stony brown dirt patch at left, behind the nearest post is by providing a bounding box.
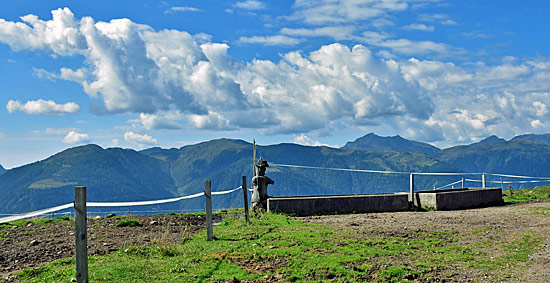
[0,215,220,282]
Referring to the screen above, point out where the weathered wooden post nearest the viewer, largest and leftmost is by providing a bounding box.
[74,187,88,283]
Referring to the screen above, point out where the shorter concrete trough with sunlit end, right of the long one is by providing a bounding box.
[414,188,503,210]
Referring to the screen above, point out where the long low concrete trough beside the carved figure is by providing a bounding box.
[267,193,409,216]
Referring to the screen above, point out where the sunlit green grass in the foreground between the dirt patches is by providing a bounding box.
[17,213,540,282]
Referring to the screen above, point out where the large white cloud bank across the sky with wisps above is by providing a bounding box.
[0,7,550,144]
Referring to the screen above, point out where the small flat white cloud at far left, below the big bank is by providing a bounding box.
[6,99,80,115]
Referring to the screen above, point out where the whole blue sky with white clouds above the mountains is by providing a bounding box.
[0,0,550,168]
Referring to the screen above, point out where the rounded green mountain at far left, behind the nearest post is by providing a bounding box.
[0,145,175,213]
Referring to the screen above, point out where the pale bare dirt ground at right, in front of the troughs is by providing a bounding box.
[301,201,550,282]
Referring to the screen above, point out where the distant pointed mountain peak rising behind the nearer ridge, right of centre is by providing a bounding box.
[342,133,440,156]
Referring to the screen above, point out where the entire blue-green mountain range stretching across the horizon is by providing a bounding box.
[0,133,550,213]
